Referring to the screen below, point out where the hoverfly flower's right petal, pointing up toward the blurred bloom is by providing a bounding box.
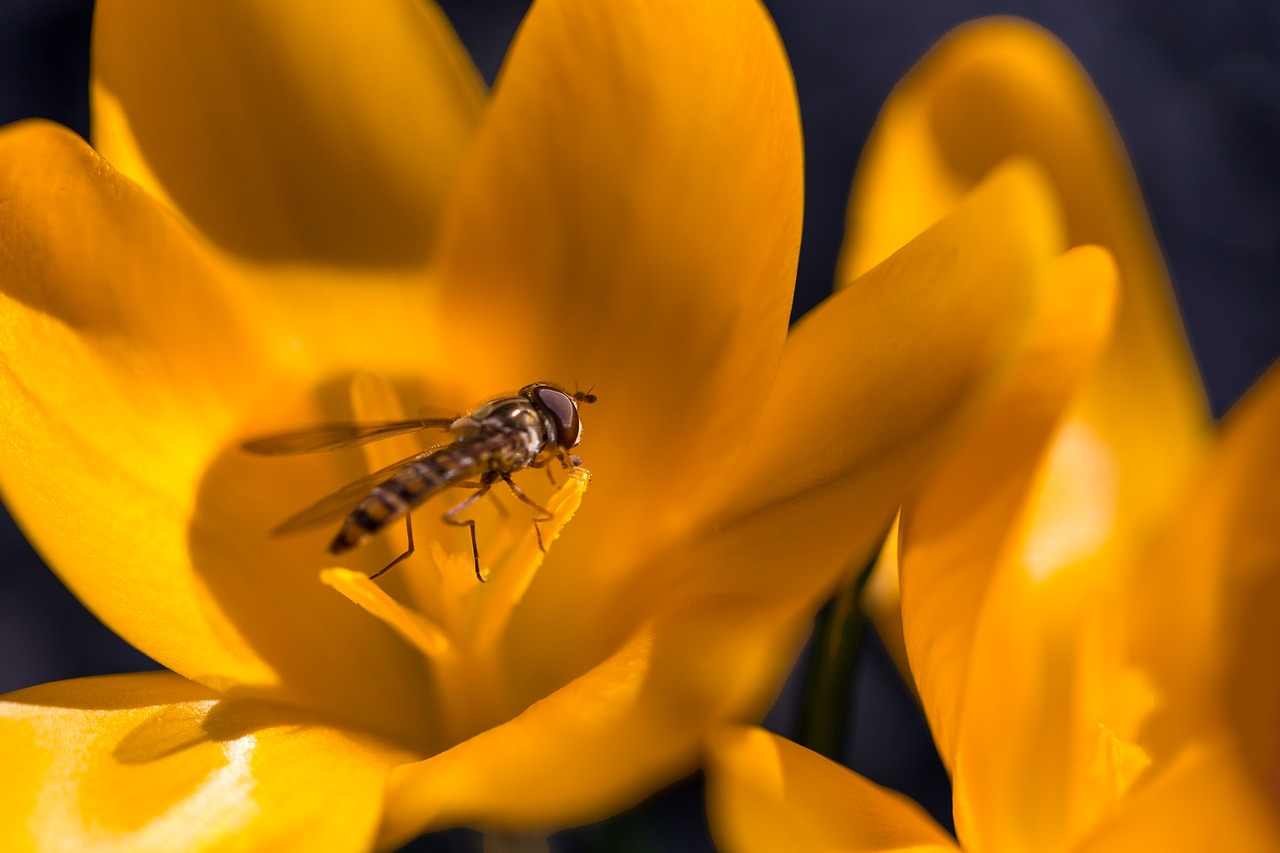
[723,156,1061,535]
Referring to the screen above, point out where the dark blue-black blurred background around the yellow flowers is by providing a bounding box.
[0,0,1280,850]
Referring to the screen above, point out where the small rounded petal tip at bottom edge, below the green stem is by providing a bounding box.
[707,727,957,853]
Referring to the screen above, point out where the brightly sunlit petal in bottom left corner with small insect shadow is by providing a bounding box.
[0,672,398,853]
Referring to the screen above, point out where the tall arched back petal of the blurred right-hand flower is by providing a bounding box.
[841,18,1208,614]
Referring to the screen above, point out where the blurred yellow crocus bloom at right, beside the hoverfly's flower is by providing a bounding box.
[709,20,1280,852]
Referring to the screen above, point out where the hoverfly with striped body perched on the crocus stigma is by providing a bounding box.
[243,382,596,581]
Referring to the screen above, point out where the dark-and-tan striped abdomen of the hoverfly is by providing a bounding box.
[329,444,481,553]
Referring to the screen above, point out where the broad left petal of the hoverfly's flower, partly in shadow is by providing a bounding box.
[0,123,435,742]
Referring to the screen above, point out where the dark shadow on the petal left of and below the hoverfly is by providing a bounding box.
[188,380,442,751]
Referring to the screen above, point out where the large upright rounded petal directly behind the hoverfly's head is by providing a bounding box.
[438,0,801,596]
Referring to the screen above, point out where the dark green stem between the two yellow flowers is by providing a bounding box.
[796,560,876,762]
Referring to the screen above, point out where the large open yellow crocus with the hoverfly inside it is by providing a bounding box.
[0,0,1059,850]
